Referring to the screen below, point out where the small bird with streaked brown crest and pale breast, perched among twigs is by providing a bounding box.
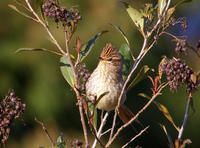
[86,43,134,123]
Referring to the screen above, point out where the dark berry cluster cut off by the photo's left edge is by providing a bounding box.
[0,91,26,143]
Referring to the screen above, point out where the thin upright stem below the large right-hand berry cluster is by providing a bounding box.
[178,93,192,140]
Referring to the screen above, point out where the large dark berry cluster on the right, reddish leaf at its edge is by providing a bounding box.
[159,58,197,93]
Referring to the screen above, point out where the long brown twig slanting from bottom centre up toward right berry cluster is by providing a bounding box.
[106,82,169,148]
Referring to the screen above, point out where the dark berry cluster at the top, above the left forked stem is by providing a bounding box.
[42,0,81,27]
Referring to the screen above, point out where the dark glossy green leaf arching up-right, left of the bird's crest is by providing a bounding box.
[79,31,108,62]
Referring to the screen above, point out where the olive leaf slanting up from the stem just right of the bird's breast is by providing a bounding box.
[128,65,151,90]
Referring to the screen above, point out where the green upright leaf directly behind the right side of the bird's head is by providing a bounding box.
[119,44,132,80]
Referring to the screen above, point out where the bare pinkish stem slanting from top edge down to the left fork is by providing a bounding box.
[25,0,66,55]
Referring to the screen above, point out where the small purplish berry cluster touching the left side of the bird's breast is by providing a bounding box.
[76,64,90,92]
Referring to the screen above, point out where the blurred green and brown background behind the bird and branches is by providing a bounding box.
[0,0,200,148]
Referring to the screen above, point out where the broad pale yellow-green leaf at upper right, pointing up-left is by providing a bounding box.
[122,2,144,36]
